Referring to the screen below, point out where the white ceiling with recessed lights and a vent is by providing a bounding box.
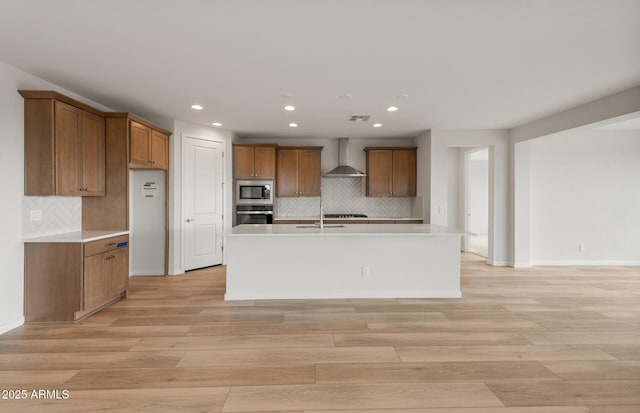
[0,0,640,137]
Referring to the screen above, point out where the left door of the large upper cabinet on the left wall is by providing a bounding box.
[55,101,84,196]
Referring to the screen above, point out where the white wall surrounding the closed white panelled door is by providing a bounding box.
[169,120,234,275]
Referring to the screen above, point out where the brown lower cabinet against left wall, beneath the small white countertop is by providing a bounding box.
[24,235,129,322]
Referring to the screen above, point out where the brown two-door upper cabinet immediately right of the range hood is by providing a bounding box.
[364,147,416,197]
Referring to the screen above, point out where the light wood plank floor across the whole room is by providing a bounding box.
[0,254,640,413]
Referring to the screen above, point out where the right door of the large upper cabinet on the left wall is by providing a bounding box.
[80,112,105,196]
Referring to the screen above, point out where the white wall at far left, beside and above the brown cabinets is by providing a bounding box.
[0,62,114,334]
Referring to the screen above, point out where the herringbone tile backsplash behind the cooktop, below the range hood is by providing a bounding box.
[275,178,414,218]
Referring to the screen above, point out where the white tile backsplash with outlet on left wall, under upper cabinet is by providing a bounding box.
[22,196,82,238]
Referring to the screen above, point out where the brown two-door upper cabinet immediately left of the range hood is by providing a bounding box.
[276,146,322,197]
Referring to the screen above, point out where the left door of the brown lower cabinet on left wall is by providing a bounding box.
[83,251,112,311]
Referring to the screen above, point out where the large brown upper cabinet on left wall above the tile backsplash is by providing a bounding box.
[19,90,105,196]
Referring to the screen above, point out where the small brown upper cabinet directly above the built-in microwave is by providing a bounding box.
[233,144,276,179]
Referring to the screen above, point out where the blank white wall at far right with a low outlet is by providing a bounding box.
[530,130,640,265]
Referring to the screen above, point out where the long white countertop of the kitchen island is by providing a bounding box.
[227,224,472,237]
